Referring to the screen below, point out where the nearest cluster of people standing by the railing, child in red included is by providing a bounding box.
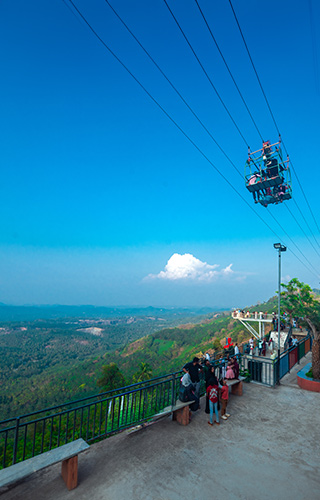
[179,354,240,425]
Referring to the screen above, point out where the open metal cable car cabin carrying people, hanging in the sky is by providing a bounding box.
[245,140,292,207]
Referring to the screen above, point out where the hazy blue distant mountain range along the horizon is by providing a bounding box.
[0,303,222,322]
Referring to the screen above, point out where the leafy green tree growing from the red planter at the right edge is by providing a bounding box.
[281,278,320,379]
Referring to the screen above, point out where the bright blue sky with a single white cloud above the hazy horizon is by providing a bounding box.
[0,0,320,308]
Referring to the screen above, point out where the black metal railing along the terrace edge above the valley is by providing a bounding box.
[0,337,312,468]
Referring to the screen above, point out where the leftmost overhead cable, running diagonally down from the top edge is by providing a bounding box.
[63,0,318,279]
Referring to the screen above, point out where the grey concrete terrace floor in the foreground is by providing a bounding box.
[0,358,320,500]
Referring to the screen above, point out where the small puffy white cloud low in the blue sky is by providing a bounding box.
[147,253,235,282]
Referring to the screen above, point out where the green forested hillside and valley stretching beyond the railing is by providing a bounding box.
[0,297,288,419]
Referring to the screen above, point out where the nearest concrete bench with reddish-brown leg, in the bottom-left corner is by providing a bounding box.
[0,439,89,490]
